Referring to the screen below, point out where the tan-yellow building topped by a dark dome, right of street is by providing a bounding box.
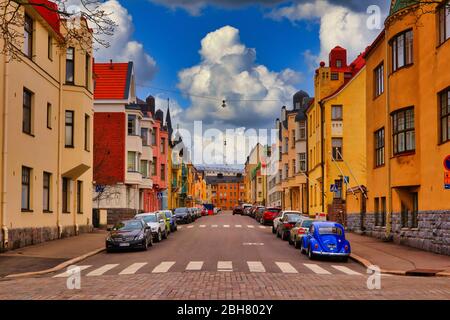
[277,91,311,212]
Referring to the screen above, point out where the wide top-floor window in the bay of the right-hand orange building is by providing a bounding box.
[391,30,413,72]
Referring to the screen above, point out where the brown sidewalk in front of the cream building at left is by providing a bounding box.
[0,230,107,277]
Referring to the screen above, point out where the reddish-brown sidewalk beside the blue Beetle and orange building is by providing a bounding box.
[346,232,450,276]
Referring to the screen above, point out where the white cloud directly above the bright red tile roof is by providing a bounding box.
[95,0,157,83]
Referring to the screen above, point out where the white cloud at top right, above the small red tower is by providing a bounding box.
[269,0,383,65]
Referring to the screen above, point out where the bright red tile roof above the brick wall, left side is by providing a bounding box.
[94,62,133,100]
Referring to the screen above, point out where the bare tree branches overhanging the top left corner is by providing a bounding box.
[0,0,116,60]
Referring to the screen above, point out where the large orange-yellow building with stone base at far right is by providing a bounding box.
[362,1,450,255]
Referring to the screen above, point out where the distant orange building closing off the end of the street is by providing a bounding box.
[206,175,245,210]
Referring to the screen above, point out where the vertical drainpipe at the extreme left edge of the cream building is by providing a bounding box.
[0,56,8,250]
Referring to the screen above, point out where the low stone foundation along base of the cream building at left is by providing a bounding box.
[0,225,93,252]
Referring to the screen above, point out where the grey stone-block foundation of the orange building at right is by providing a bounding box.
[347,211,450,255]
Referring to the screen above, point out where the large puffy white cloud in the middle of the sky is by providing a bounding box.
[178,26,301,128]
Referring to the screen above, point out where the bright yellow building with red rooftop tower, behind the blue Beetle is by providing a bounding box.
[306,47,366,223]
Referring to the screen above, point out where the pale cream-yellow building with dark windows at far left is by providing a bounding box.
[0,6,93,250]
